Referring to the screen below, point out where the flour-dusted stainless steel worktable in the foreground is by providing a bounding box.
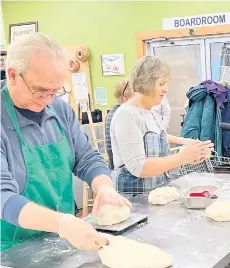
[1,173,230,268]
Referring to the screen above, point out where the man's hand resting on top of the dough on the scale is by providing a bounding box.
[92,186,131,215]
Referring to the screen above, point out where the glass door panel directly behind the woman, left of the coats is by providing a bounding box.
[147,38,206,136]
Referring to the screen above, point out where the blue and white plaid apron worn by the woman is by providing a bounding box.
[116,108,170,198]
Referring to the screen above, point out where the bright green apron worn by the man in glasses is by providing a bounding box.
[0,88,74,251]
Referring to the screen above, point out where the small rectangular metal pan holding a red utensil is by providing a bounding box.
[184,185,217,209]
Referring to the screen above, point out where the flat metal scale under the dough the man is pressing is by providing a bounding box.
[85,213,148,235]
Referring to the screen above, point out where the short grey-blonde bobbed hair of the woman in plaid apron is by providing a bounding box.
[131,55,170,96]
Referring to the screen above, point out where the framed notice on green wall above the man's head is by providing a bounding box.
[9,21,38,43]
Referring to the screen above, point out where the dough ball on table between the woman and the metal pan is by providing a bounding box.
[148,186,180,205]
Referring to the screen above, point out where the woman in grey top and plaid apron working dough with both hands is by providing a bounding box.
[110,56,213,197]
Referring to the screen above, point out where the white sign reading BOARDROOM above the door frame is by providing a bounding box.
[163,12,230,30]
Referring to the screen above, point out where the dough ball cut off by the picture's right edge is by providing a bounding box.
[206,200,230,221]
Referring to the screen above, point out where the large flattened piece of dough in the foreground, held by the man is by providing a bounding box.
[98,234,172,268]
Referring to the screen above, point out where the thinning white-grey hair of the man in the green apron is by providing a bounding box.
[6,32,68,78]
